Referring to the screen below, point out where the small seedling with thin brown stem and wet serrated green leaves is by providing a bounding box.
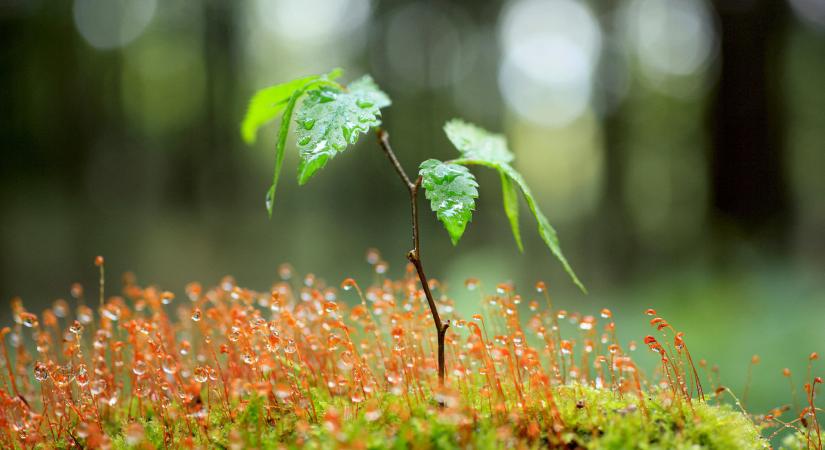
[241,69,585,385]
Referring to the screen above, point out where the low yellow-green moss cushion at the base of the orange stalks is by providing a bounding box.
[127,384,760,450]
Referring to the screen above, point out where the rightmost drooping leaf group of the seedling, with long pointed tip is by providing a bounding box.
[444,119,587,292]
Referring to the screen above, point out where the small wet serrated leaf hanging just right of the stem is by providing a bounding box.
[418,159,478,245]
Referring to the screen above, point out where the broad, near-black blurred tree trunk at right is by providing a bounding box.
[710,0,790,247]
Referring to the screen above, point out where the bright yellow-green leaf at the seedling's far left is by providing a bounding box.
[241,75,320,145]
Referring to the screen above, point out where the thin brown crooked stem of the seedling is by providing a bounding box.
[376,128,450,386]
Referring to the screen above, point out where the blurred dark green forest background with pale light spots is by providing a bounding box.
[0,0,825,420]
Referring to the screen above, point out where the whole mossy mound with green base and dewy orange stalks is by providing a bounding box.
[0,250,822,448]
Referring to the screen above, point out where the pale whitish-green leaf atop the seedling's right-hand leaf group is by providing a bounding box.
[444,119,514,163]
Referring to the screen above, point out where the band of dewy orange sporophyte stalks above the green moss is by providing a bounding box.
[6,249,812,444]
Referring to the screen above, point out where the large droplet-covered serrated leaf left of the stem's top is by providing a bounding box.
[296,76,390,184]
